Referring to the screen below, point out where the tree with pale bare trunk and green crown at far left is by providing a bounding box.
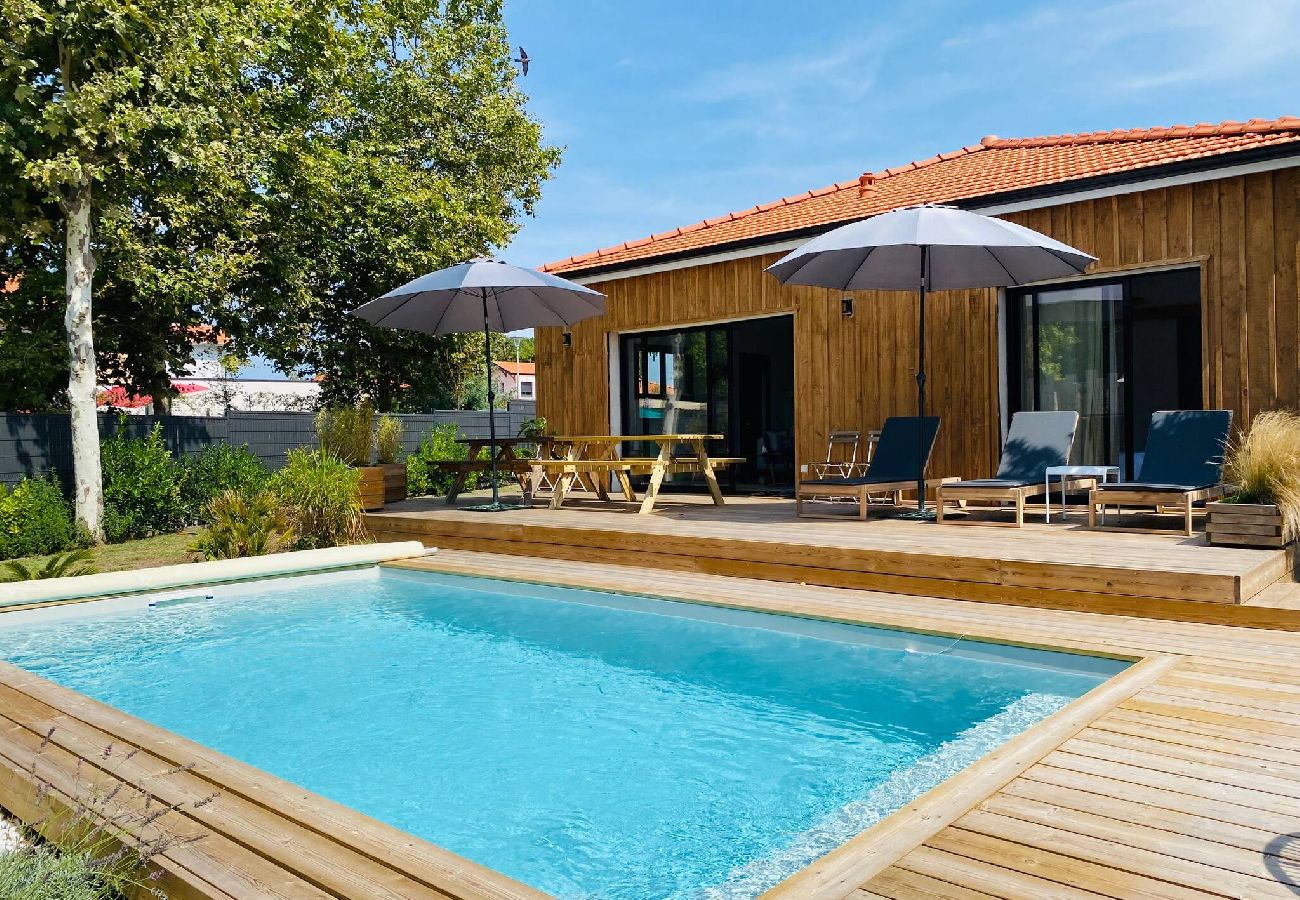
[0,0,276,537]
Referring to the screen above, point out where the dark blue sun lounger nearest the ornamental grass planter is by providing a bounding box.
[1088,410,1232,536]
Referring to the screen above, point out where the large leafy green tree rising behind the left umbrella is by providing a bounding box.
[220,0,559,411]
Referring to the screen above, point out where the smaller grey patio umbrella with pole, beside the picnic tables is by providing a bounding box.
[352,258,605,511]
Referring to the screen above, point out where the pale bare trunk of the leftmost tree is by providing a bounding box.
[64,181,104,542]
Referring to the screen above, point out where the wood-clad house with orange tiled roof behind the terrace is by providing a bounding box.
[536,117,1300,489]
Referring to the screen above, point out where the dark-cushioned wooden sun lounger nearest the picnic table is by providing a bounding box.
[794,416,957,519]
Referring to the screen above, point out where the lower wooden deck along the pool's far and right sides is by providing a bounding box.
[397,551,1300,900]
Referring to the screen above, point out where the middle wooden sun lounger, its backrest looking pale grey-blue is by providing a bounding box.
[935,411,1096,528]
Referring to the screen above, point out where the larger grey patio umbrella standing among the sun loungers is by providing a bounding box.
[767,204,1096,515]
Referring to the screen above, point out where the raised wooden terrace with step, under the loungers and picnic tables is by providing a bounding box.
[367,494,1300,629]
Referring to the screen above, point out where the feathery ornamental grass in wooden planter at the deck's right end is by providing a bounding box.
[1205,410,1300,548]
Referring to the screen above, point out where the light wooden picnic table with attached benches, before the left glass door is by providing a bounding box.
[527,434,744,515]
